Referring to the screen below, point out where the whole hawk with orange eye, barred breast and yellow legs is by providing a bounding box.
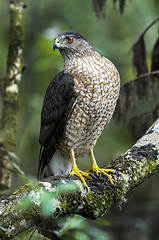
[38,31,120,186]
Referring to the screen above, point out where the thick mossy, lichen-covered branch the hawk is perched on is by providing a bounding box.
[0,119,159,239]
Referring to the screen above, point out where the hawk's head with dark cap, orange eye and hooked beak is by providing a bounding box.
[53,31,93,58]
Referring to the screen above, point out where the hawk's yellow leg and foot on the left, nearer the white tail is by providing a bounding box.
[70,149,90,187]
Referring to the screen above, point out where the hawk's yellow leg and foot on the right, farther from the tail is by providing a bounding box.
[86,149,115,185]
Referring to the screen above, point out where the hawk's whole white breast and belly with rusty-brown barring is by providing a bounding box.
[59,51,120,157]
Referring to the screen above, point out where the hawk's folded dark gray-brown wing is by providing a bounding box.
[38,71,77,177]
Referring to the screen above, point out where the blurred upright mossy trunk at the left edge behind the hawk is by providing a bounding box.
[0,0,24,195]
